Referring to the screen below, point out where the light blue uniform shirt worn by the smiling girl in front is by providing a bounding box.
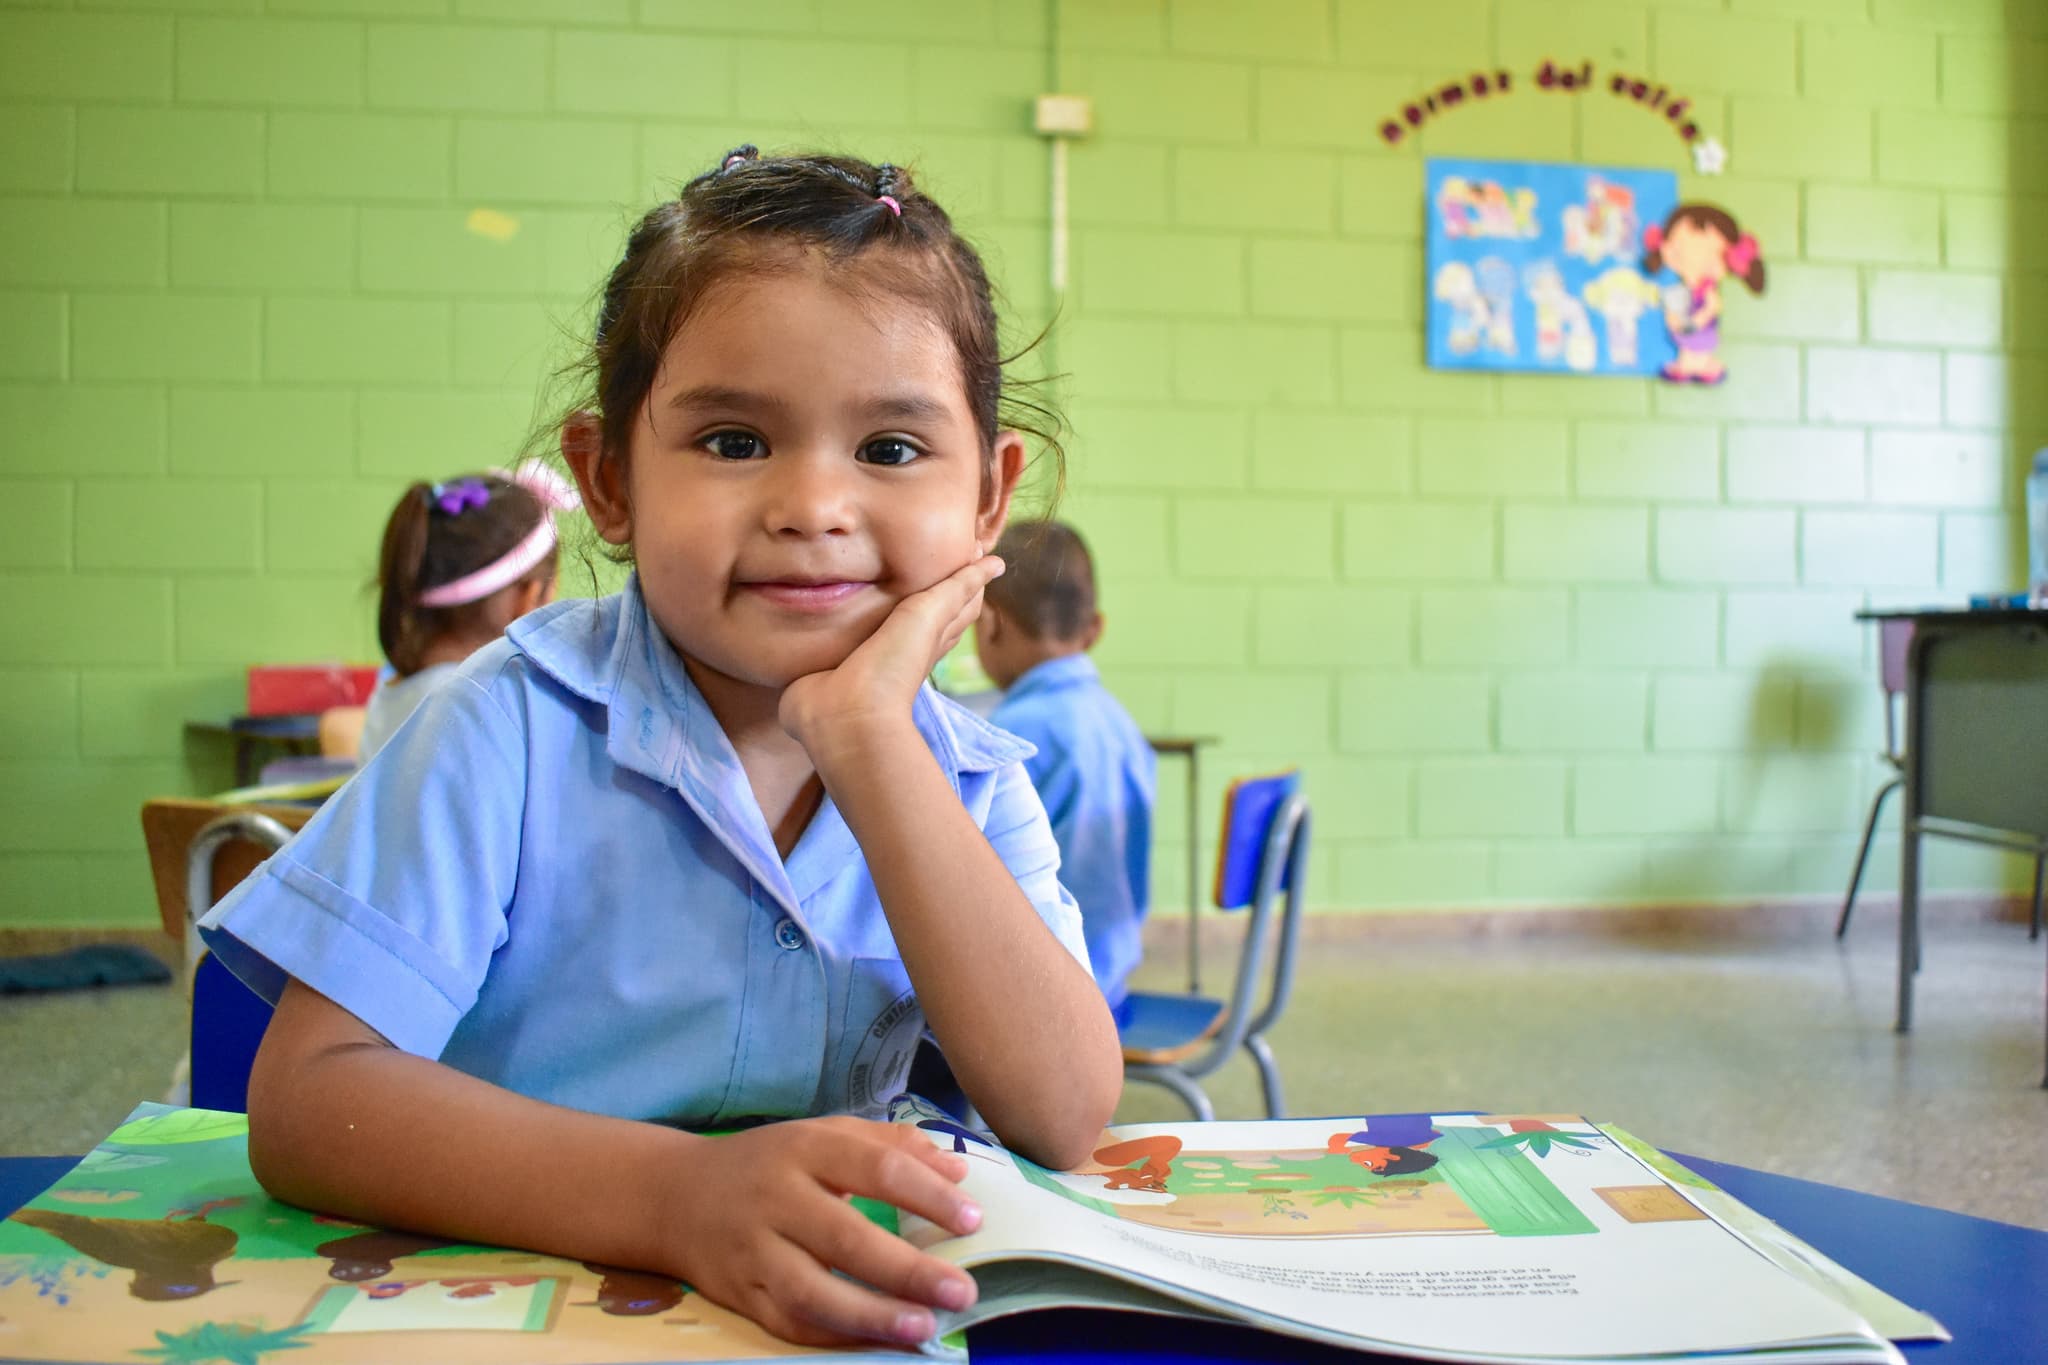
[201,579,1085,1126]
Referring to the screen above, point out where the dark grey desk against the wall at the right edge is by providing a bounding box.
[1855,610,2048,1088]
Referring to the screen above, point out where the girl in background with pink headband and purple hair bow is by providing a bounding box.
[360,460,578,761]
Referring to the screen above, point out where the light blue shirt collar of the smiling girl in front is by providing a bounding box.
[506,573,1036,911]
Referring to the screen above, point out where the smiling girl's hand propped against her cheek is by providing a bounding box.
[780,555,1004,763]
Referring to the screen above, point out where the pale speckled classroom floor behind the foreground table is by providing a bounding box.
[0,905,2048,1228]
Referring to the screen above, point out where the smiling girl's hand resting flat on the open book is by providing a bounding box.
[662,1117,981,1347]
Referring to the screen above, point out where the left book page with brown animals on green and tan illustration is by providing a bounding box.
[0,1105,903,1365]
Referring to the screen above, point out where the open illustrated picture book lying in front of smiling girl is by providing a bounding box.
[0,1097,1944,1365]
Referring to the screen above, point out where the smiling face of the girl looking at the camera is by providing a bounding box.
[584,258,1024,692]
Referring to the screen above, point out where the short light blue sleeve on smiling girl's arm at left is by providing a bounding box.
[199,671,526,1056]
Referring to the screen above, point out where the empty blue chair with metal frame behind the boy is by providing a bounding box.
[1116,769,1309,1121]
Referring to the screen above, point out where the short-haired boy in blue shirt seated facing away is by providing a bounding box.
[975,522,1157,1007]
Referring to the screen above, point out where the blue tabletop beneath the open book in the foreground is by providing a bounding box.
[0,1144,2048,1365]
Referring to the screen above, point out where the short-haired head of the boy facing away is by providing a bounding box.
[975,522,1102,688]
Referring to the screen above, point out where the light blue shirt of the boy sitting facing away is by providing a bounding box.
[989,655,1159,1005]
